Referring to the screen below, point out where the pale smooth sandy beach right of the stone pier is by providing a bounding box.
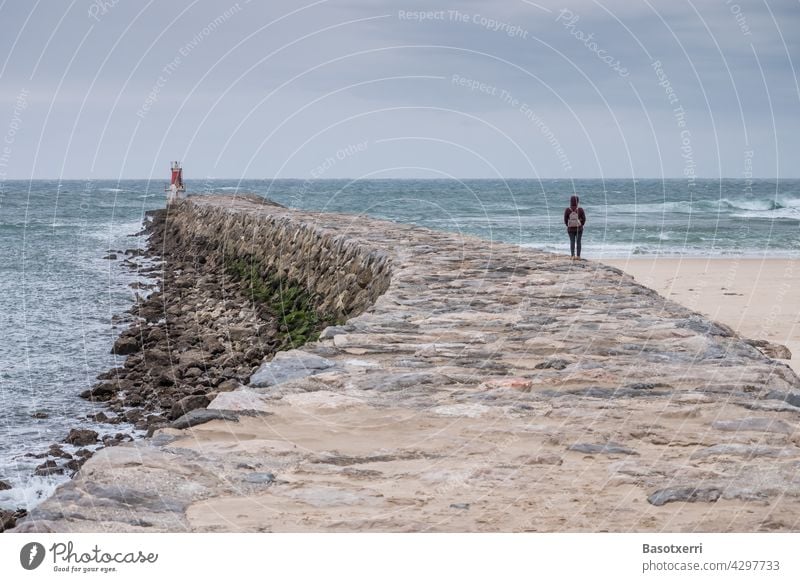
[603,258,800,371]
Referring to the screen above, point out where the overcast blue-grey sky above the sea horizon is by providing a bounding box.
[0,0,800,180]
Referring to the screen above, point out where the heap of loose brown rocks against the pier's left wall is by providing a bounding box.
[81,201,304,432]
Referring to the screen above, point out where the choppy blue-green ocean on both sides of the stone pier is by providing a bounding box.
[0,180,800,508]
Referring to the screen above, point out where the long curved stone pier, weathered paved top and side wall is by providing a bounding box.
[16,196,800,532]
